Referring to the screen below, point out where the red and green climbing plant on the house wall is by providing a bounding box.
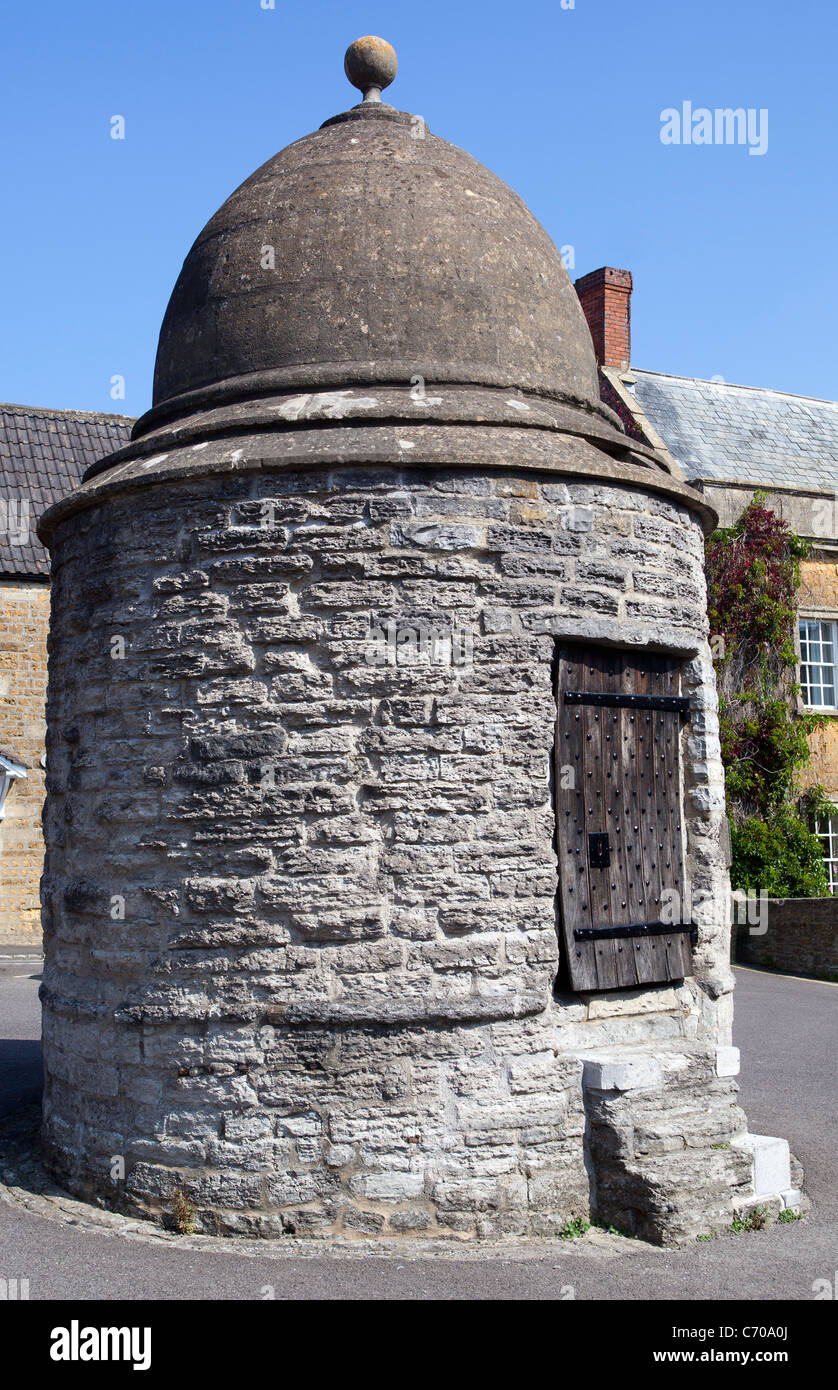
[706,492,832,897]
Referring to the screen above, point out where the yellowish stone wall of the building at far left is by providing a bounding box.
[0,580,50,945]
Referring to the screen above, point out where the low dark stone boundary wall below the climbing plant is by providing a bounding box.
[737,897,838,979]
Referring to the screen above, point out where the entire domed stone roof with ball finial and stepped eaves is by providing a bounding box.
[44,38,710,534]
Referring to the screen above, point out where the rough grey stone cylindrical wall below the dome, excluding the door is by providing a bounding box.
[43,468,741,1234]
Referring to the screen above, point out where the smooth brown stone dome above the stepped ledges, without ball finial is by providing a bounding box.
[154,101,600,414]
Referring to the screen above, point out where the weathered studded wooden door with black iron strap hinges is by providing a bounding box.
[556,644,692,990]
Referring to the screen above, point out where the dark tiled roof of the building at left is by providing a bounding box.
[0,404,133,578]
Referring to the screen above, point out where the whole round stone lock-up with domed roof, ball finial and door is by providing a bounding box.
[40,40,772,1240]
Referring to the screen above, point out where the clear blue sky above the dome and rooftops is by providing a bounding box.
[0,0,838,414]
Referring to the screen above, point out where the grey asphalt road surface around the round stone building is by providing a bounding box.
[0,956,838,1301]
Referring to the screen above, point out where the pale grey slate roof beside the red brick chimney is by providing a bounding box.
[631,367,838,491]
